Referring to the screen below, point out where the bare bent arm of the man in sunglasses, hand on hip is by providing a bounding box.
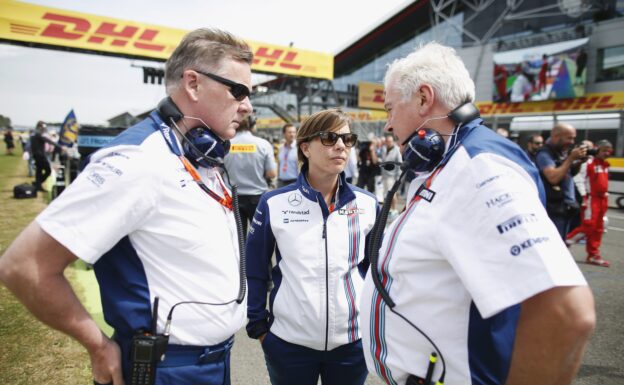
[0,221,123,385]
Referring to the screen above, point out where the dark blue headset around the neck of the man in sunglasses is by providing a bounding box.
[156,96,230,168]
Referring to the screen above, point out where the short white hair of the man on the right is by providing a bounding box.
[384,42,475,109]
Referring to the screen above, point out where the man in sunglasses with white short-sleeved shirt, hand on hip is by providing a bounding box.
[0,29,253,385]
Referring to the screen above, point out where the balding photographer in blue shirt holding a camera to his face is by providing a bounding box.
[536,123,587,239]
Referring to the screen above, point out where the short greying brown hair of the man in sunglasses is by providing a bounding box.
[165,28,253,95]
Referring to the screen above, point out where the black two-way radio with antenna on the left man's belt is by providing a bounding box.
[130,297,169,385]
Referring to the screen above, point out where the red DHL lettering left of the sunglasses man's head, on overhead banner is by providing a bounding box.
[11,12,165,52]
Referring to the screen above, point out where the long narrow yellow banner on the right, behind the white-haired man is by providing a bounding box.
[476,91,624,116]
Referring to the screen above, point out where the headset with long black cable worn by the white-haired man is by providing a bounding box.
[368,102,480,385]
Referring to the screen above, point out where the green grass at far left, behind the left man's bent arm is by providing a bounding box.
[0,152,92,385]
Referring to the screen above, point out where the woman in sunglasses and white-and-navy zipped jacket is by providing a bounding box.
[247,109,377,385]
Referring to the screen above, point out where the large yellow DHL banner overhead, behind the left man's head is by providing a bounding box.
[0,0,334,79]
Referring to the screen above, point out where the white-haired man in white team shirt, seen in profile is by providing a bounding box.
[361,43,595,385]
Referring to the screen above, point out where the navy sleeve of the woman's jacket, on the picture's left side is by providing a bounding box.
[245,194,275,338]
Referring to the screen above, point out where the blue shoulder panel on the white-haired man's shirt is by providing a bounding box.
[459,121,546,204]
